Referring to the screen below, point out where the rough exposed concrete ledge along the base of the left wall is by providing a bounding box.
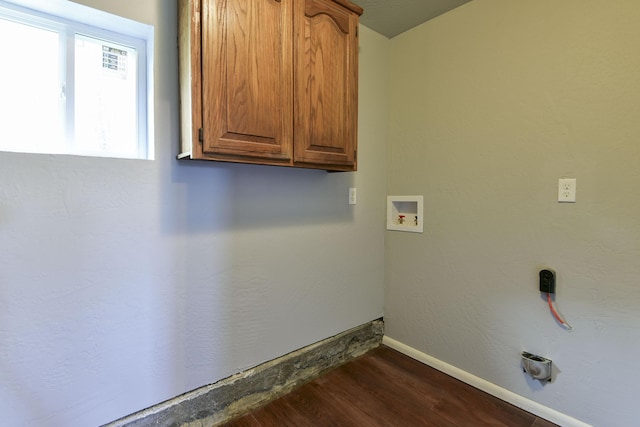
[103,319,384,427]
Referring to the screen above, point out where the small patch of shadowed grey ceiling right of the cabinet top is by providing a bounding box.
[353,0,470,38]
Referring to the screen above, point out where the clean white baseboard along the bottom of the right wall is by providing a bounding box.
[382,335,592,427]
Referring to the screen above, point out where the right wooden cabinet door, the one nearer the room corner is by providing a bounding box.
[294,0,359,170]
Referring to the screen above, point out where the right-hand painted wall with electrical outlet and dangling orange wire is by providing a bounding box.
[385,0,640,427]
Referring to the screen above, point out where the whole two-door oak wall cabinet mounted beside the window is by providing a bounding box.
[178,0,362,171]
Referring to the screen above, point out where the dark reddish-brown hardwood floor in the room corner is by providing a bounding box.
[225,346,555,427]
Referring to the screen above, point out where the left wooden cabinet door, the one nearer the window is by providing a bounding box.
[201,0,293,164]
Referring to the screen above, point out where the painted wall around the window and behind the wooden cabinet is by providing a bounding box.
[0,0,389,427]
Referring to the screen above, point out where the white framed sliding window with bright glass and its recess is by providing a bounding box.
[0,0,154,159]
